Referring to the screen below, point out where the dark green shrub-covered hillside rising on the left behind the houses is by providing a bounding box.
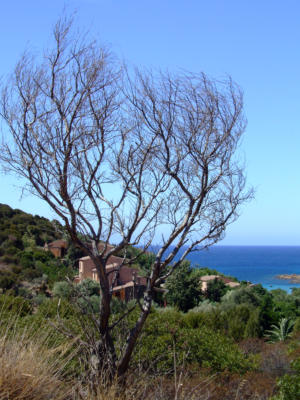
[0,204,74,297]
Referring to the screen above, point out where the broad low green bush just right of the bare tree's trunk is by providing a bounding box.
[135,310,254,373]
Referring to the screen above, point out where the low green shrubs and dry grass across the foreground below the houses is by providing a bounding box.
[0,283,299,400]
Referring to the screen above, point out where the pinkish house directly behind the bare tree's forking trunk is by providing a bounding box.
[75,256,147,301]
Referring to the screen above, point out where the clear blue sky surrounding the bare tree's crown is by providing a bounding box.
[0,0,300,245]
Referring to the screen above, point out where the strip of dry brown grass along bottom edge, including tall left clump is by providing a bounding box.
[0,312,275,400]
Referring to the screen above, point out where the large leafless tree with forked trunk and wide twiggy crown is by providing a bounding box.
[0,20,251,384]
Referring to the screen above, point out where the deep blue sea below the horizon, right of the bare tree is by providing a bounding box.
[171,246,300,292]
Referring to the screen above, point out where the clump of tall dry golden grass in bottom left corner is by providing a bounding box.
[0,321,74,400]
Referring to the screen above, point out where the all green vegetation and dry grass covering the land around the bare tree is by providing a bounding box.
[0,205,300,400]
